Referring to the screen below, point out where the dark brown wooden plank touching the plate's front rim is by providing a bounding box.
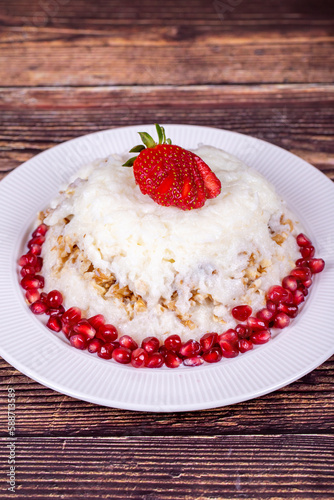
[0,357,334,437]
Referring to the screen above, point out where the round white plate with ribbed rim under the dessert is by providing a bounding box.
[0,125,334,411]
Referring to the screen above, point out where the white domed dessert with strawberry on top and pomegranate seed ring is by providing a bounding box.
[19,127,324,368]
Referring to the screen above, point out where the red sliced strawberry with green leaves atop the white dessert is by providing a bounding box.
[123,124,221,210]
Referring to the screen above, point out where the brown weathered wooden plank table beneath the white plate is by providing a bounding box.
[0,0,334,500]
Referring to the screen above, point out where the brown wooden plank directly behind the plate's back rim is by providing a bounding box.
[0,85,334,178]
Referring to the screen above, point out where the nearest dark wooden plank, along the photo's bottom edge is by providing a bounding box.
[0,435,334,500]
